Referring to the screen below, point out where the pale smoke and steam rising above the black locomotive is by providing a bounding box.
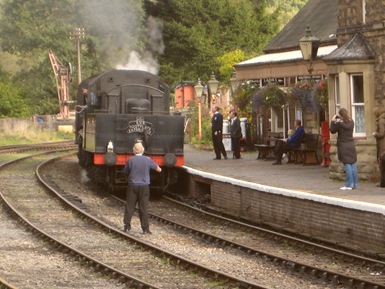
[80,0,164,74]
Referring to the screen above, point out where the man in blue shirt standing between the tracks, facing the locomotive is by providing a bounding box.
[123,143,162,234]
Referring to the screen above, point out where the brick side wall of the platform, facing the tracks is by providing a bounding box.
[182,173,385,254]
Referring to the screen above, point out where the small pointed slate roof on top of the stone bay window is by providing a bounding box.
[323,33,375,60]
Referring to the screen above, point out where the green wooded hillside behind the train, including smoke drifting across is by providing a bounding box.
[0,0,306,119]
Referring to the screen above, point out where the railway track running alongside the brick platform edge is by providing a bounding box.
[33,154,384,288]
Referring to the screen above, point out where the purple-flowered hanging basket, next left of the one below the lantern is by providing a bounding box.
[253,83,286,111]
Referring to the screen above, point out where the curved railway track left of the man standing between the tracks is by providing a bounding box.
[1,148,272,288]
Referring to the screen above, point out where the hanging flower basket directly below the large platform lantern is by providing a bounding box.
[290,80,328,112]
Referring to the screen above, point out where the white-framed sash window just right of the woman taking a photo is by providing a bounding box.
[350,74,365,136]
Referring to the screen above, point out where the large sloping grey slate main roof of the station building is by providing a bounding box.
[265,0,338,53]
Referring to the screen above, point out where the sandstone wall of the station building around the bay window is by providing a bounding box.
[329,0,385,181]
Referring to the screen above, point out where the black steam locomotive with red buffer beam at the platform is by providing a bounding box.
[75,70,184,191]
